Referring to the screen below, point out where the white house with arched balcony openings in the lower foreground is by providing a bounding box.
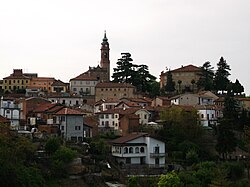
[112,133,166,167]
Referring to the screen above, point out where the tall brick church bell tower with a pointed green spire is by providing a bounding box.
[100,31,110,79]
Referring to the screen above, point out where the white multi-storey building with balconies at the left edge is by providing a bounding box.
[0,97,21,130]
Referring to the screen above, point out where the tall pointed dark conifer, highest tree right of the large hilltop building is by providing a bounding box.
[214,57,231,93]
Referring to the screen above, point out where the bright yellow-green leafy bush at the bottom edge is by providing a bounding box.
[158,171,183,187]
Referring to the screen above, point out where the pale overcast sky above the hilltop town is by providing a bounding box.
[0,0,250,95]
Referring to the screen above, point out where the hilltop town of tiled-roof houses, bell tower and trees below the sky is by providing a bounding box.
[0,33,250,186]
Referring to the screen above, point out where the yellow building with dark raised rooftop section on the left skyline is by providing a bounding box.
[2,69,31,92]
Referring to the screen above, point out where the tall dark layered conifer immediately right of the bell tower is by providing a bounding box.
[112,53,137,83]
